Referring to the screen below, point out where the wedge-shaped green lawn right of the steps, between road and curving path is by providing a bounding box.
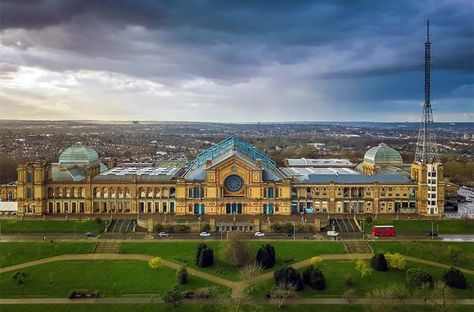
[370,241,474,269]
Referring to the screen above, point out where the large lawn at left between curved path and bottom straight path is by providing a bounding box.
[0,260,226,298]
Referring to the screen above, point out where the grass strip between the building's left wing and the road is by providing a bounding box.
[0,220,104,234]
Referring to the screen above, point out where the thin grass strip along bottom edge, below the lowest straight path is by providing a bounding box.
[2,303,472,312]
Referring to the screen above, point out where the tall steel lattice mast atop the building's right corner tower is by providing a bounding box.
[415,21,439,165]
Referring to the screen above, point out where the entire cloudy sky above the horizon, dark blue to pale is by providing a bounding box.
[0,0,474,122]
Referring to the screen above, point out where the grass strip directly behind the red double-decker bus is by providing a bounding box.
[366,219,474,235]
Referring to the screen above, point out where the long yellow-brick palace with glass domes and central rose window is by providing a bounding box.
[0,136,444,218]
